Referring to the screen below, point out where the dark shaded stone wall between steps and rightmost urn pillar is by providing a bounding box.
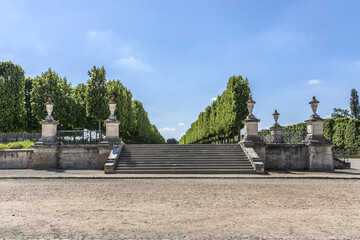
[264,143,309,171]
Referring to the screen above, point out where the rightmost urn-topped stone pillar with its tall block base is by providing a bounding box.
[304,96,334,171]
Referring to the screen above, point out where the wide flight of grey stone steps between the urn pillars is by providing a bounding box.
[115,144,255,174]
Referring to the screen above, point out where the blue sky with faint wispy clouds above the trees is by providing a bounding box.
[0,0,360,139]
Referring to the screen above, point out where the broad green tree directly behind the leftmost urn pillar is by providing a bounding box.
[31,68,74,130]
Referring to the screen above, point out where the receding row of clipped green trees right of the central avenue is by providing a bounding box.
[180,76,250,144]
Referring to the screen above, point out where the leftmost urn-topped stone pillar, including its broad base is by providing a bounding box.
[28,99,59,169]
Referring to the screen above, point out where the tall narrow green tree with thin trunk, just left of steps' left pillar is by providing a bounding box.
[86,66,110,130]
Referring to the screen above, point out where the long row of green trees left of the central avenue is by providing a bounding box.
[0,62,165,143]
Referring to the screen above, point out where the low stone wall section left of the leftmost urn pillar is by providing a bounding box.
[0,149,34,169]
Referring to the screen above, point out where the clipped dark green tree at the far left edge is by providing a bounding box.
[0,62,25,132]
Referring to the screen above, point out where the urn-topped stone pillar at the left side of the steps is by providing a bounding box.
[102,100,121,145]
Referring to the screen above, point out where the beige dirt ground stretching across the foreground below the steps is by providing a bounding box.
[0,179,360,239]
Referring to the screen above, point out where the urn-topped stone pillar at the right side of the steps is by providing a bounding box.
[240,96,264,147]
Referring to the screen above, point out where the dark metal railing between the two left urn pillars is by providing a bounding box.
[57,129,105,144]
